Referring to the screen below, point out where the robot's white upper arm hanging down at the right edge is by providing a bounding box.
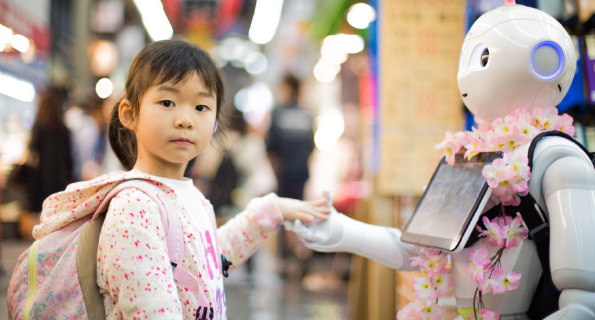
[542,157,595,320]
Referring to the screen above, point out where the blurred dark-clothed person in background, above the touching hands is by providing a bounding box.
[266,74,314,276]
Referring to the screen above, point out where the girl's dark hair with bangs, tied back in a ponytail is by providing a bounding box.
[107,40,225,170]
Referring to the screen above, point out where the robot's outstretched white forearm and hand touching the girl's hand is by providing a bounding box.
[285,208,418,271]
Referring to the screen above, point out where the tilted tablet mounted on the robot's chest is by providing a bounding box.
[402,153,501,251]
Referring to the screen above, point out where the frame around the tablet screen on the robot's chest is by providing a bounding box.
[401,152,502,252]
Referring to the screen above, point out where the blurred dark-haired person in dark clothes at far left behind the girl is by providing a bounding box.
[27,88,73,215]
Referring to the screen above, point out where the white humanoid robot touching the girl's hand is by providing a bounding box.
[291,3,595,320]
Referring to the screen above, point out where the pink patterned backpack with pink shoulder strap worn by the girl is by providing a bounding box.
[8,180,217,320]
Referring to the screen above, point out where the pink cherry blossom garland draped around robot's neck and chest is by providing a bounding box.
[397,107,574,320]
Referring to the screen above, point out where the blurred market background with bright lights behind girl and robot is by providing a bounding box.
[0,0,595,320]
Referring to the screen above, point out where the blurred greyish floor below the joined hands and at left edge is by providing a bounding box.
[0,240,349,320]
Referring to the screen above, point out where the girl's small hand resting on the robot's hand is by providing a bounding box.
[277,197,331,223]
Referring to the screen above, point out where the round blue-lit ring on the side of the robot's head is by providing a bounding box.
[529,41,566,81]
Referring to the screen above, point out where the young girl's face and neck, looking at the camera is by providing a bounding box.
[128,73,217,179]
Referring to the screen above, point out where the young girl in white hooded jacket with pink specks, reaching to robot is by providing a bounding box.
[88,40,329,319]
